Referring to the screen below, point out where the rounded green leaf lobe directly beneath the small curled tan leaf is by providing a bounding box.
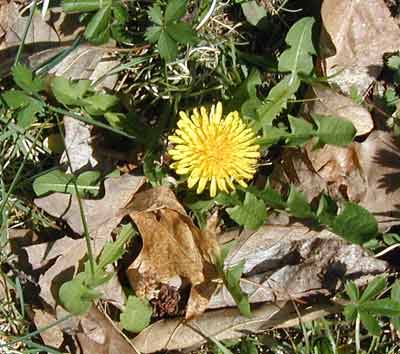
[312,115,357,146]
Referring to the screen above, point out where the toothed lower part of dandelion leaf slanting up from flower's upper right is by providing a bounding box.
[254,76,300,133]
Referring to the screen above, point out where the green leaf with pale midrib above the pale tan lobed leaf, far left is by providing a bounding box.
[33,170,100,197]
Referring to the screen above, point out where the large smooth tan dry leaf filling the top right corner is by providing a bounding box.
[321,0,400,93]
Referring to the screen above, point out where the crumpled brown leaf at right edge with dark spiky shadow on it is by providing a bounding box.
[282,130,400,232]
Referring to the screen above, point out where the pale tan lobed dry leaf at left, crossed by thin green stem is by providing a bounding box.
[33,175,144,307]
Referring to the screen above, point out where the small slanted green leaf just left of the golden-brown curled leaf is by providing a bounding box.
[98,224,136,269]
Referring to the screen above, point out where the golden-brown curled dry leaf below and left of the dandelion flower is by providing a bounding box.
[127,187,218,317]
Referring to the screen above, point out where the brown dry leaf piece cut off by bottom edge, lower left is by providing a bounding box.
[77,306,139,354]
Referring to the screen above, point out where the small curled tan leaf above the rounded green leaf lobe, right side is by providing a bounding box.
[303,85,374,136]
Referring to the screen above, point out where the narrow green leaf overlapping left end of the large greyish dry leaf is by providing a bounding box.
[224,261,251,317]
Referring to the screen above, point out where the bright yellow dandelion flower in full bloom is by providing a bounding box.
[168,102,260,197]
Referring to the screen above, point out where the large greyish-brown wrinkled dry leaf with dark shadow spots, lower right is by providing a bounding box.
[209,225,388,308]
